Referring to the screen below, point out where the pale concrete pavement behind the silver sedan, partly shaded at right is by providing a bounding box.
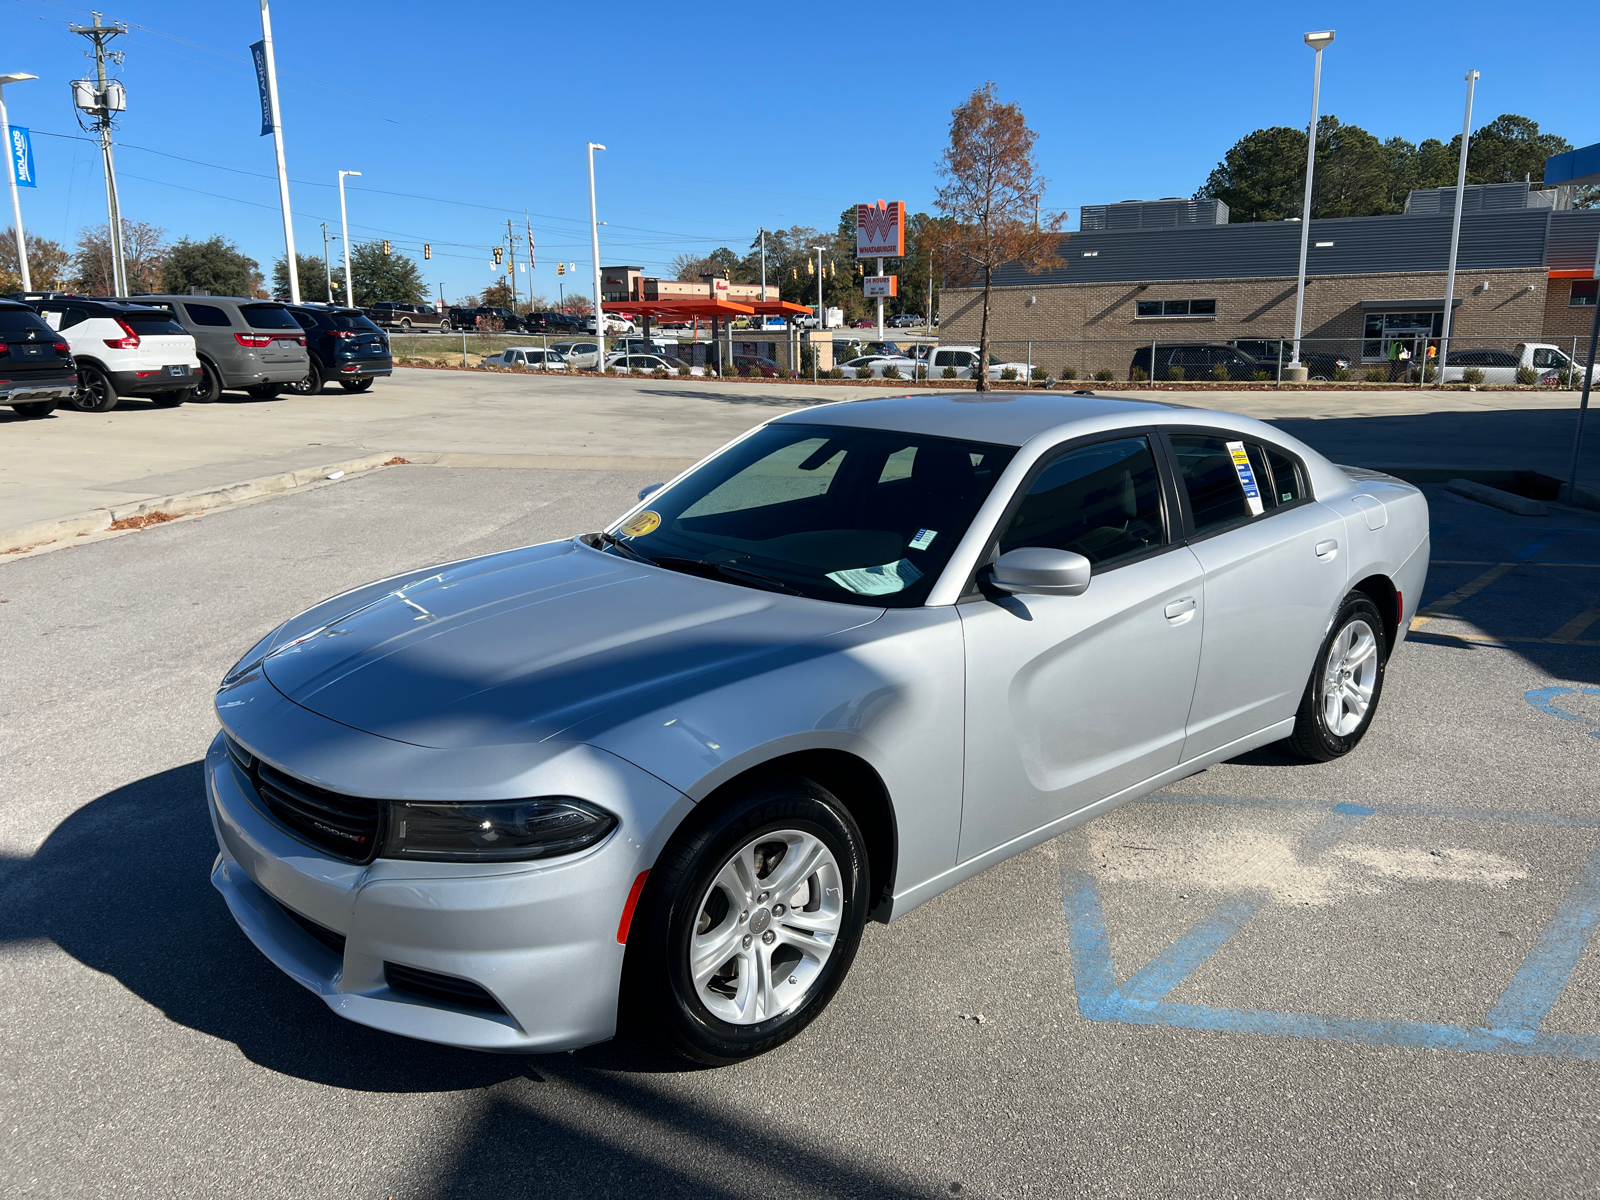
[0,370,1600,553]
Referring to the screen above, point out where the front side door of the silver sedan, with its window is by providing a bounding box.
[957,430,1205,859]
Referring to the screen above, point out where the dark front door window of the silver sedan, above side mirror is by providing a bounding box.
[1000,437,1166,566]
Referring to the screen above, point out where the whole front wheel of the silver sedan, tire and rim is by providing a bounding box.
[622,778,869,1066]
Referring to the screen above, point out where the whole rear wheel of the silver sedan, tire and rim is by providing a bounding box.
[1288,592,1389,763]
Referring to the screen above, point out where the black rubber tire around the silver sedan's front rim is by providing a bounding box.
[624,779,869,1066]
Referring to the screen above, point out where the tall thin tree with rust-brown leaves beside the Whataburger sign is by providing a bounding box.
[938,82,1066,392]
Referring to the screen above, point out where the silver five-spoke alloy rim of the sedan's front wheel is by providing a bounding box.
[688,829,845,1026]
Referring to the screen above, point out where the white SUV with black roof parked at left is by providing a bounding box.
[32,296,200,413]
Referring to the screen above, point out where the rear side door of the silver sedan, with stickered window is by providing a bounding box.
[1166,429,1347,758]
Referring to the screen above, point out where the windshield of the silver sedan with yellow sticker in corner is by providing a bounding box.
[608,422,1016,608]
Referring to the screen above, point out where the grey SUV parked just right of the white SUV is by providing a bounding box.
[134,296,310,402]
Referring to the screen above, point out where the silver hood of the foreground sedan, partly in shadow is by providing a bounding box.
[262,541,883,747]
